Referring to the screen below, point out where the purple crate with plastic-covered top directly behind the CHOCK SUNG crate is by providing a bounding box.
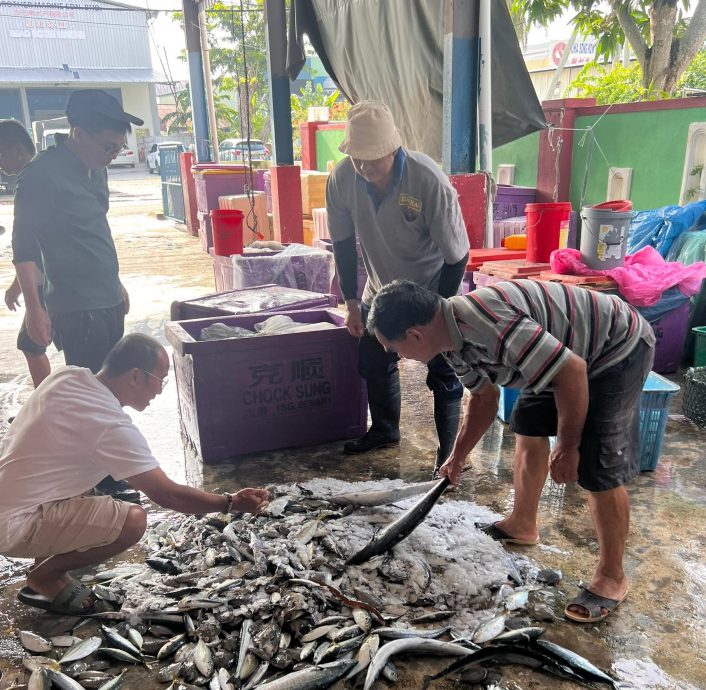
[171,285,337,321]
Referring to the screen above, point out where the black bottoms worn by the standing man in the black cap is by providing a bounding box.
[51,302,125,374]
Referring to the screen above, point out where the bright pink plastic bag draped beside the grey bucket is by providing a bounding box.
[549,247,706,307]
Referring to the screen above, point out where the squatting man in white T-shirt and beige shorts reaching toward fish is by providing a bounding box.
[0,333,269,615]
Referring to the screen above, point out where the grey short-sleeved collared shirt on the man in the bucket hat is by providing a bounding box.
[326,149,469,304]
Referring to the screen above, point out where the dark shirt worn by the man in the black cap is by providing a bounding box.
[12,144,123,314]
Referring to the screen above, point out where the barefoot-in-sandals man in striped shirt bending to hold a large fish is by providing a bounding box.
[368,280,655,622]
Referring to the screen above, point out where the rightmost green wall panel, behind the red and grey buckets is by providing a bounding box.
[571,108,706,210]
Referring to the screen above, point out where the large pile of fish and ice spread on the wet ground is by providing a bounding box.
[12,484,613,690]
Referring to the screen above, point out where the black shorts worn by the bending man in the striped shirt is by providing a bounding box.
[510,340,654,491]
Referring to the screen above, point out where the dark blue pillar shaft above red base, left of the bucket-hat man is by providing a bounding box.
[265,0,294,165]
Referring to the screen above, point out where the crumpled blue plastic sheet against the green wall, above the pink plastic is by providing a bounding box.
[628,200,706,258]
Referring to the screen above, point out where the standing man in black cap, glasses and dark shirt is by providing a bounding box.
[12,89,143,374]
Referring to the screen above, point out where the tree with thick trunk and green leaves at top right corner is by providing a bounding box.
[512,0,706,95]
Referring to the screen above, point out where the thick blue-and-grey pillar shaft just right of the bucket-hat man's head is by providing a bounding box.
[441,0,480,174]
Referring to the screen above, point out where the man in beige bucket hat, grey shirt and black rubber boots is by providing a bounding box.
[326,101,469,473]
